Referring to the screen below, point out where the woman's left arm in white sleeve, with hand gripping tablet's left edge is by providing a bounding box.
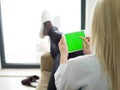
[54,37,68,90]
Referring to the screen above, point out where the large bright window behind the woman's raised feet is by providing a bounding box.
[0,0,85,67]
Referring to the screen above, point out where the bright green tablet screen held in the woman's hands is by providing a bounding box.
[65,31,85,53]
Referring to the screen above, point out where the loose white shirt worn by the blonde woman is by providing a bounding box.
[55,54,109,90]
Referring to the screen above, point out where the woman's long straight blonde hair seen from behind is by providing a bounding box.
[91,0,120,90]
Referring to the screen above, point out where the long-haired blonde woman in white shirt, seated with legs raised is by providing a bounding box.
[39,0,120,90]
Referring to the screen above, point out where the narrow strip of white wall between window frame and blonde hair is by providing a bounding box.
[86,0,97,36]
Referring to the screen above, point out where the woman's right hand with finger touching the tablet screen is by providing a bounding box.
[80,37,92,55]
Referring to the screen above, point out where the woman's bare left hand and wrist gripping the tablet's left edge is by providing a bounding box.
[58,37,68,64]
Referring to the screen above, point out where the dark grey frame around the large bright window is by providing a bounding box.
[0,0,86,68]
